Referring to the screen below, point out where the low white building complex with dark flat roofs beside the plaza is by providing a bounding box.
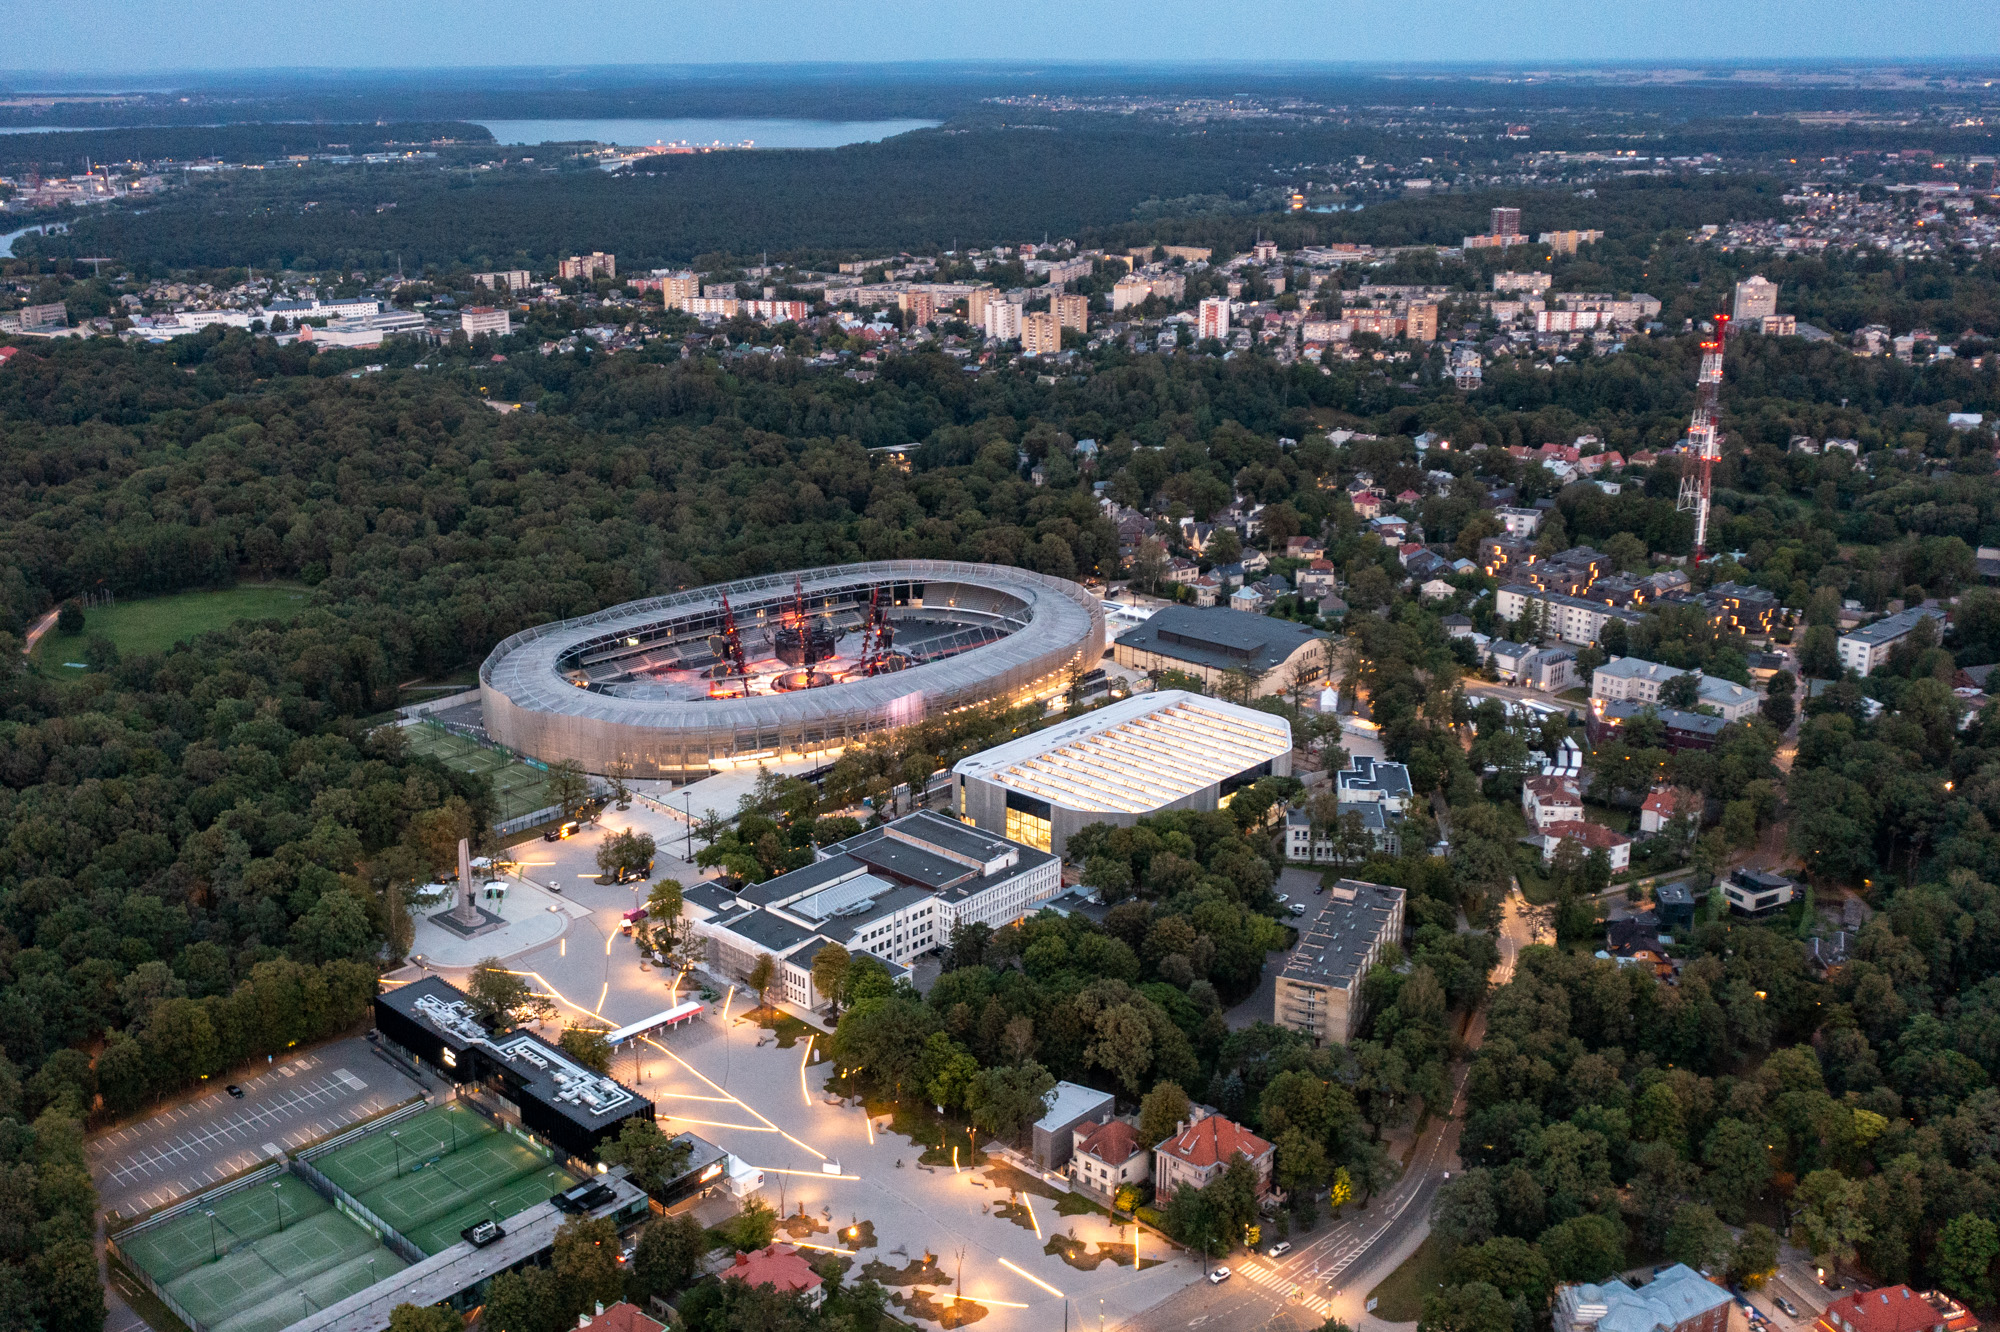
[682,810,1062,1008]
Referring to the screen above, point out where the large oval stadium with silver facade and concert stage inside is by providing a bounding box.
[480,560,1106,780]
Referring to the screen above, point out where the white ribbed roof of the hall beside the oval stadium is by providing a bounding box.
[956,690,1292,814]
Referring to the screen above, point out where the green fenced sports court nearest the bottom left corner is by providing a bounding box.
[118,1174,404,1332]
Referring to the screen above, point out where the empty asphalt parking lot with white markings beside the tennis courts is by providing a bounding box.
[88,1036,420,1216]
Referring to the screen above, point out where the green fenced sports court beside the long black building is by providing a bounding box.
[312,1104,576,1254]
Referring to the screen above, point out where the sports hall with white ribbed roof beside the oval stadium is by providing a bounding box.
[952,688,1292,856]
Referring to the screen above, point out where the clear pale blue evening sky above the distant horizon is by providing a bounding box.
[0,0,2000,74]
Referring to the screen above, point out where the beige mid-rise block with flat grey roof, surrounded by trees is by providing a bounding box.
[1272,878,1406,1046]
